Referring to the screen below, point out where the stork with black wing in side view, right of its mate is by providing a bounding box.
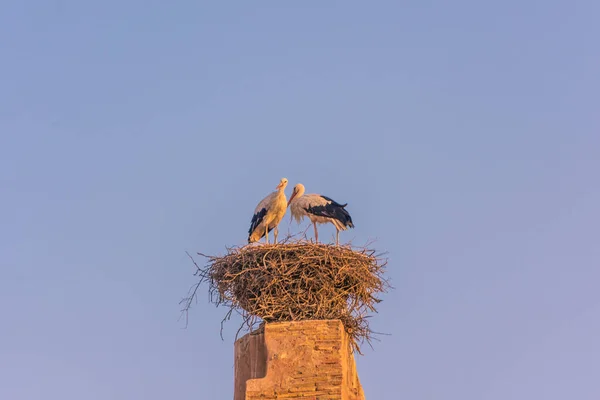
[288,183,354,245]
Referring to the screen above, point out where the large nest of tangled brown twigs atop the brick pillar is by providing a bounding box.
[183,241,389,353]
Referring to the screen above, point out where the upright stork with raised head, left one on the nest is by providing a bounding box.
[248,178,288,243]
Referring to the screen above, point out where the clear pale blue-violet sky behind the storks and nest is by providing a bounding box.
[0,0,600,400]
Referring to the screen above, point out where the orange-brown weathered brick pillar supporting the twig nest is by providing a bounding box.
[234,320,365,400]
